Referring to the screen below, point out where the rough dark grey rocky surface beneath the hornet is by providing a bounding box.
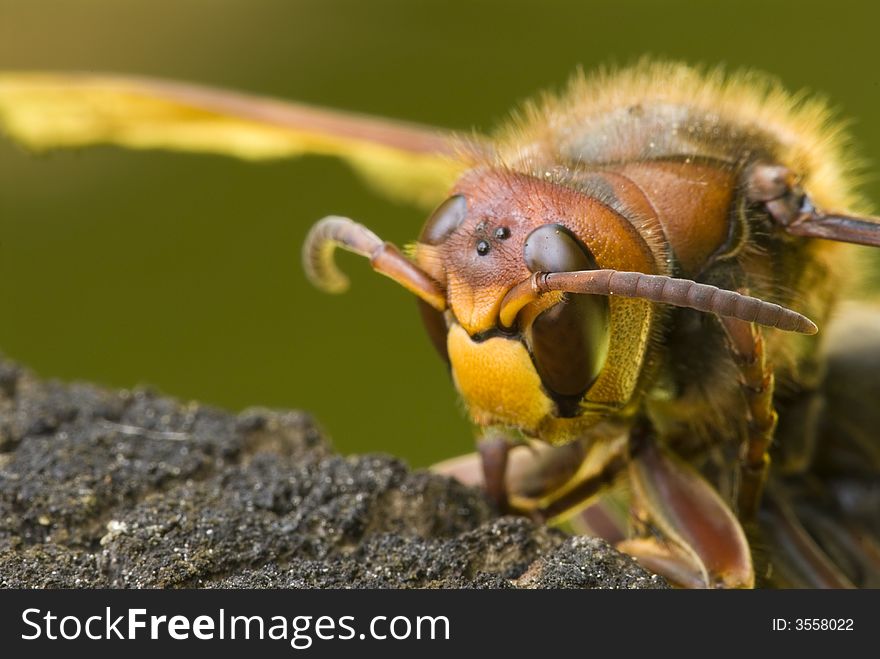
[0,361,665,588]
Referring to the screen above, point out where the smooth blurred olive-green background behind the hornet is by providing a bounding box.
[0,0,880,465]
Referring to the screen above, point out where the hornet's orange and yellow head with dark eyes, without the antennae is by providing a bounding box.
[415,169,656,443]
